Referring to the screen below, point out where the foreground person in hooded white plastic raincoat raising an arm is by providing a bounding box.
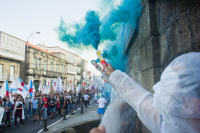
[91,52,200,133]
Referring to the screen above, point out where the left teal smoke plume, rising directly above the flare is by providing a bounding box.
[56,11,101,49]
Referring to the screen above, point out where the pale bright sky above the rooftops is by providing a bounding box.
[0,0,103,75]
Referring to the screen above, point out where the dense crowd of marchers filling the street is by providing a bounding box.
[0,89,106,128]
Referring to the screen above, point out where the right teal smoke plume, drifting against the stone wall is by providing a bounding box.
[100,0,142,71]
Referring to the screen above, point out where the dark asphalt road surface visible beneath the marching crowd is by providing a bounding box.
[0,103,97,133]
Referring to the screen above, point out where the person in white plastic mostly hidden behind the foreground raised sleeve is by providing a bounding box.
[95,65,137,133]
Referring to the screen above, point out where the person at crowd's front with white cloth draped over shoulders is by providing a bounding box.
[14,97,24,127]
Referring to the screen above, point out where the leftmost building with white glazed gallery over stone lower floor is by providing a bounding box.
[0,31,25,87]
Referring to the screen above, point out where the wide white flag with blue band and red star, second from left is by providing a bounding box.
[10,78,28,99]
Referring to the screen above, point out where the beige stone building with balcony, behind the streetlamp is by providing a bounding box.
[25,44,67,90]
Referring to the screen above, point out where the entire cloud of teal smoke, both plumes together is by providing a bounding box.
[57,0,142,71]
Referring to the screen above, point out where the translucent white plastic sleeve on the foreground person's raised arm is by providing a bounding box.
[109,70,160,133]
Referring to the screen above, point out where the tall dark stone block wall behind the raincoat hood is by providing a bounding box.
[124,0,200,133]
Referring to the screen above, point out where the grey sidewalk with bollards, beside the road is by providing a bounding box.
[40,103,98,133]
